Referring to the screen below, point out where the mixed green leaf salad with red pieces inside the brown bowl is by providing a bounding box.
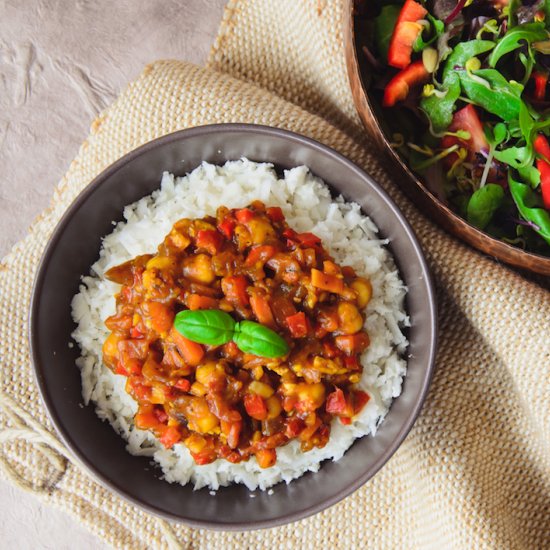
[356,0,550,256]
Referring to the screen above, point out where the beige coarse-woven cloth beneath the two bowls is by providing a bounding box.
[0,0,550,550]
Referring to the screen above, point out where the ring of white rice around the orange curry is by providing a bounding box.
[72,159,409,490]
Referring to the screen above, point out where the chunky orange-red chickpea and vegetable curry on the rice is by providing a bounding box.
[103,201,372,468]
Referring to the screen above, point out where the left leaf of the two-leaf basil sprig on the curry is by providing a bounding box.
[174,309,236,346]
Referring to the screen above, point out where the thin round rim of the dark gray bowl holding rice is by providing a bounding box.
[27,123,438,531]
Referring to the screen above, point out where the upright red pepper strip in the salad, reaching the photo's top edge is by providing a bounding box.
[388,0,428,69]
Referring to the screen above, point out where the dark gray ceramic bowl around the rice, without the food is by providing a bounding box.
[30,124,436,530]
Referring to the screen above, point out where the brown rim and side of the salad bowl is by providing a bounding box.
[343,0,550,275]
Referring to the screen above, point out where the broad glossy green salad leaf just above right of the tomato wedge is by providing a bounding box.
[459,69,523,121]
